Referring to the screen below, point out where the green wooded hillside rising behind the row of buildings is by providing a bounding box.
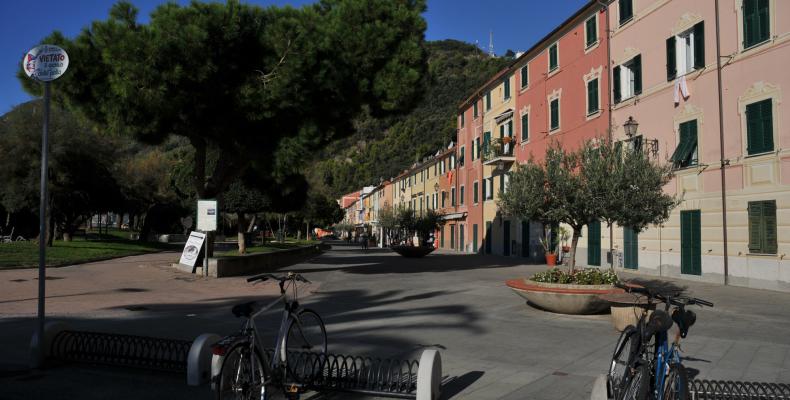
[306,40,511,198]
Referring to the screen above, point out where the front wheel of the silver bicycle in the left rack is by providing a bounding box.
[282,308,327,378]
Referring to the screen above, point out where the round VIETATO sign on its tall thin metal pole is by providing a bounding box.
[22,44,69,366]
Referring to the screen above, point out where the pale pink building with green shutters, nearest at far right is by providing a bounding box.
[600,0,790,290]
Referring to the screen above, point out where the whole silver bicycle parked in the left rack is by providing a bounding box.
[211,272,327,400]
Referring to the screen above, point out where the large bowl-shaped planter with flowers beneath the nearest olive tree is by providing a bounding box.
[506,279,623,315]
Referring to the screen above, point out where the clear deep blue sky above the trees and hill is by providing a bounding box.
[0,0,587,115]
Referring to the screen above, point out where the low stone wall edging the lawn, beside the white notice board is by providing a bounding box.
[208,244,329,278]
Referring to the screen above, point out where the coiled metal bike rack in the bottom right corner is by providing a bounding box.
[689,379,790,400]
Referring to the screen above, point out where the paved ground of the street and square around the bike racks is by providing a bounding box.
[0,246,790,400]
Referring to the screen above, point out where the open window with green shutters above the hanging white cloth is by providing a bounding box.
[667,22,705,81]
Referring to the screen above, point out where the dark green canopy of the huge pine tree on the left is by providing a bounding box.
[19,0,427,197]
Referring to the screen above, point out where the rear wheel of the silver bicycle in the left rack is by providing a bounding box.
[217,343,271,400]
